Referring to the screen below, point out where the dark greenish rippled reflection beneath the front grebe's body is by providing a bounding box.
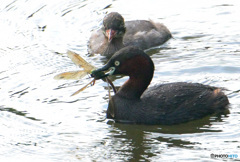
[104,112,228,161]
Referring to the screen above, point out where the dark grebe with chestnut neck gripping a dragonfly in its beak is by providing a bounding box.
[92,46,229,125]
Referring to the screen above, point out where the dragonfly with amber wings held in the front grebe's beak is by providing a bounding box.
[54,51,116,96]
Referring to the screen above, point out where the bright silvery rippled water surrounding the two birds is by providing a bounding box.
[0,0,240,161]
